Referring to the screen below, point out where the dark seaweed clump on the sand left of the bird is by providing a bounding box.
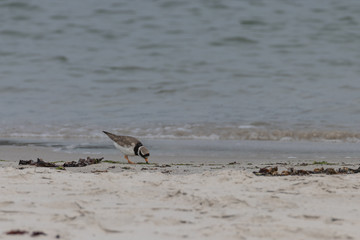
[19,157,104,170]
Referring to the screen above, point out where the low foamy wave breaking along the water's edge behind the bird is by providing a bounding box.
[0,124,360,142]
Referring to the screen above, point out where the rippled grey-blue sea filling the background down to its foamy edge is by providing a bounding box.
[0,0,360,142]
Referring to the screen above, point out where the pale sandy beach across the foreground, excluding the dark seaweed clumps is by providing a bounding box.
[0,146,360,239]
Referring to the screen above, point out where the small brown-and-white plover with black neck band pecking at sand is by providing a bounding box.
[103,131,150,164]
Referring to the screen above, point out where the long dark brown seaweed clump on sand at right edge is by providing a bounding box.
[253,166,360,176]
